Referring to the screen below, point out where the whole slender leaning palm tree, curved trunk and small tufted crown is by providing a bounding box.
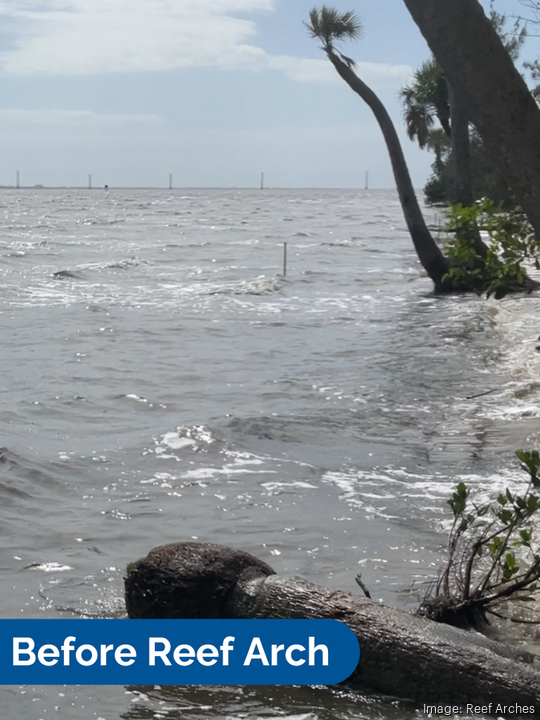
[305,5,450,291]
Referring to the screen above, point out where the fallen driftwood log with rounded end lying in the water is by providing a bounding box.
[125,542,540,718]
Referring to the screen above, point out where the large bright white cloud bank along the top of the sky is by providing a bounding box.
[0,0,411,86]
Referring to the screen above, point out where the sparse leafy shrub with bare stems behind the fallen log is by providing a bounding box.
[432,450,540,615]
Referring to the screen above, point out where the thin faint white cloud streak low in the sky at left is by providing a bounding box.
[0,108,161,127]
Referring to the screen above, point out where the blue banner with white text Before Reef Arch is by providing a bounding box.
[0,620,360,685]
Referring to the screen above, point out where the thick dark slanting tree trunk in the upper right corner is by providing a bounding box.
[404,0,540,242]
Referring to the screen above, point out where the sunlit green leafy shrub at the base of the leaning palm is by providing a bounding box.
[443,198,540,299]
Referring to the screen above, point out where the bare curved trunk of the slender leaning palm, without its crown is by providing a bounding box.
[326,48,449,291]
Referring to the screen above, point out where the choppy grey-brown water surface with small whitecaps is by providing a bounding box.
[0,190,540,720]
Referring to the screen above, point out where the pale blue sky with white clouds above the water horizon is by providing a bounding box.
[0,0,540,188]
